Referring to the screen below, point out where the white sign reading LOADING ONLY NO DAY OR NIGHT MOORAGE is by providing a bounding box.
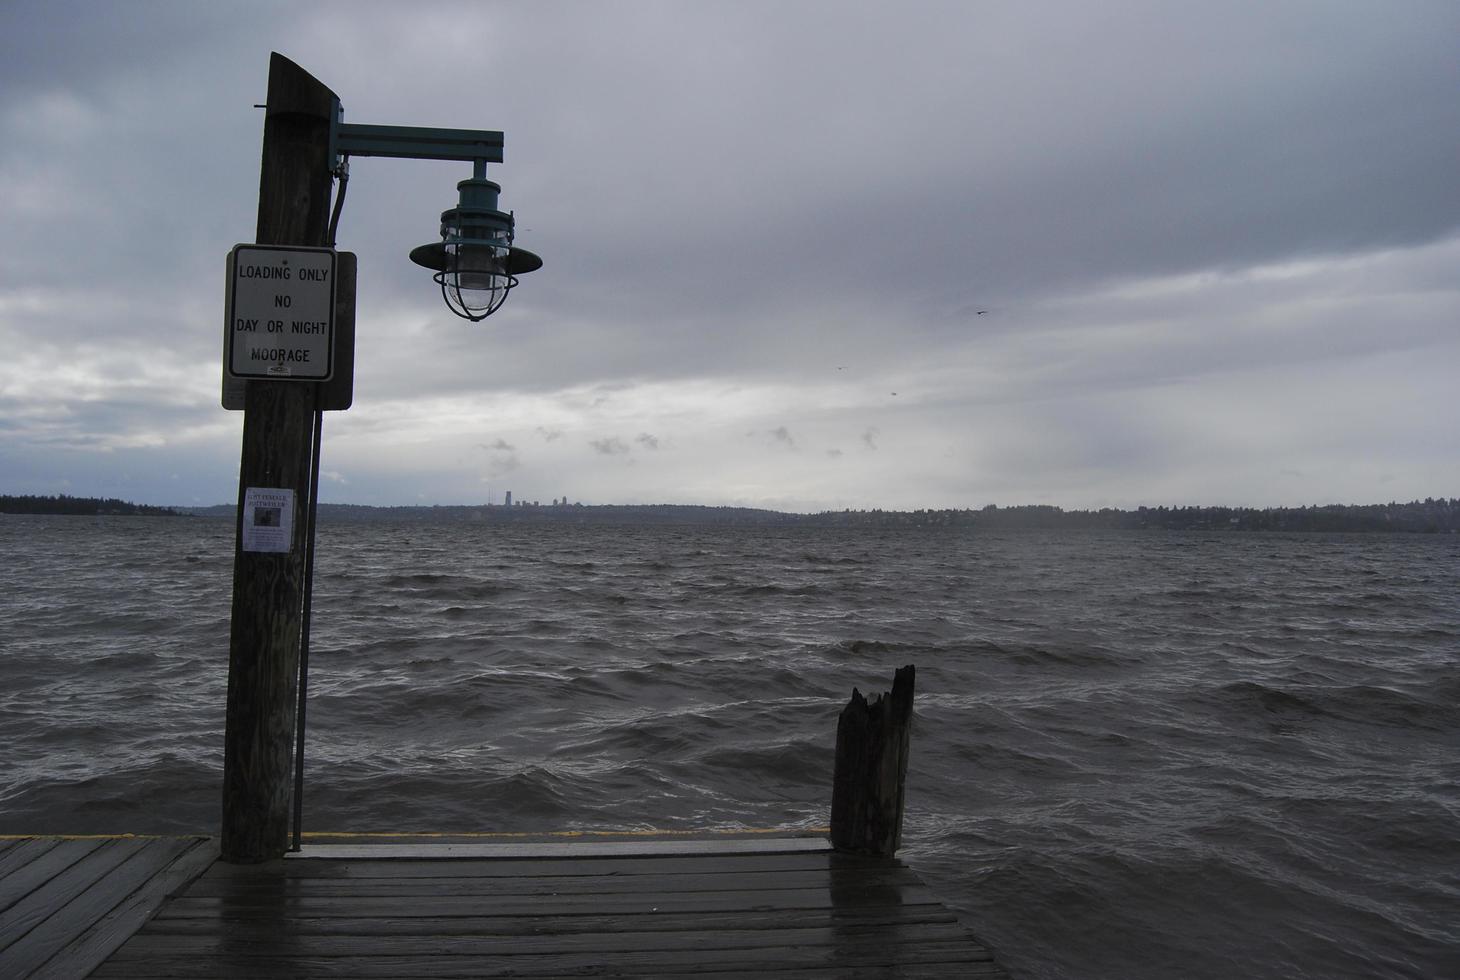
[223,245,336,381]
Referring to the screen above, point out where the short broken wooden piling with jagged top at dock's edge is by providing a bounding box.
[831,665,917,857]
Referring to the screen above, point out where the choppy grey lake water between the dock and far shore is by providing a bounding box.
[0,517,1460,979]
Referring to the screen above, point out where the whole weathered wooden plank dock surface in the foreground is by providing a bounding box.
[0,838,1006,980]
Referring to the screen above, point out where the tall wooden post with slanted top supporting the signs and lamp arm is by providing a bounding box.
[220,54,336,863]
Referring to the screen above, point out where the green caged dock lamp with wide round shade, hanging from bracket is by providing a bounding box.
[410,161,543,323]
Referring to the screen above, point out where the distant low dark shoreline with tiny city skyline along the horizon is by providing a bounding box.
[0,495,1460,533]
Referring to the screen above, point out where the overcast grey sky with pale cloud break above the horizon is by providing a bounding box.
[0,0,1460,511]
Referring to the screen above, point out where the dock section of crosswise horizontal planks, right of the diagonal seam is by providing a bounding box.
[93,841,1003,980]
